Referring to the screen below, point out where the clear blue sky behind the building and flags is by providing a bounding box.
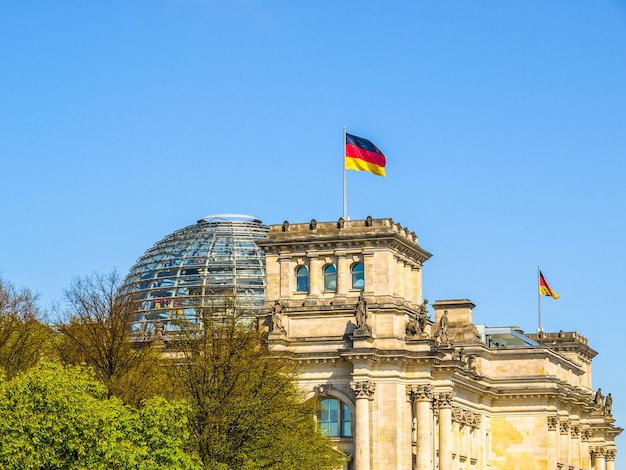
[0,0,626,456]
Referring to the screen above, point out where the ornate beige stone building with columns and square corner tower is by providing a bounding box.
[258,217,622,470]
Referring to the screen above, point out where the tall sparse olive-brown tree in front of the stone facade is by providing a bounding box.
[170,302,341,470]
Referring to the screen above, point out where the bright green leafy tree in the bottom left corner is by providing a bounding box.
[0,363,200,470]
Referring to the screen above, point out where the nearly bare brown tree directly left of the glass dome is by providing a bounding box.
[56,271,166,406]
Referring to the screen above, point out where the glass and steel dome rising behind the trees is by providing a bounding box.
[124,214,268,333]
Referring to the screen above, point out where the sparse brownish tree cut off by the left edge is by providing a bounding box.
[0,278,51,378]
